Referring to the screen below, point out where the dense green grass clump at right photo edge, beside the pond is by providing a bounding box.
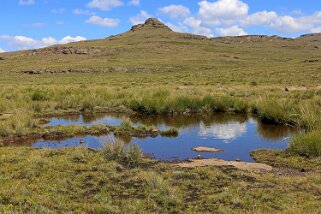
[289,131,321,157]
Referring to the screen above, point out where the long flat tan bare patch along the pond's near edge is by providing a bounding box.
[173,159,273,172]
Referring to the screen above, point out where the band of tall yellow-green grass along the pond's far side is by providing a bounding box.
[0,82,321,155]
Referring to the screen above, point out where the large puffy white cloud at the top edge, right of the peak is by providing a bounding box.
[198,0,249,26]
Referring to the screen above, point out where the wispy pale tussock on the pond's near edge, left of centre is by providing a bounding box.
[103,140,142,167]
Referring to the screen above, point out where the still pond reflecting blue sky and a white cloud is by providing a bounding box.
[32,114,297,162]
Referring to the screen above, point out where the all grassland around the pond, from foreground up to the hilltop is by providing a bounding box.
[0,19,321,213]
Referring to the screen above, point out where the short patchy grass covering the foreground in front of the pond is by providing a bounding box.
[0,148,321,213]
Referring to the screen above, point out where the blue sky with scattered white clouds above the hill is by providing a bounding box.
[0,0,321,52]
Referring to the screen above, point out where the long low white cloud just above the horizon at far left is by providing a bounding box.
[0,35,86,50]
